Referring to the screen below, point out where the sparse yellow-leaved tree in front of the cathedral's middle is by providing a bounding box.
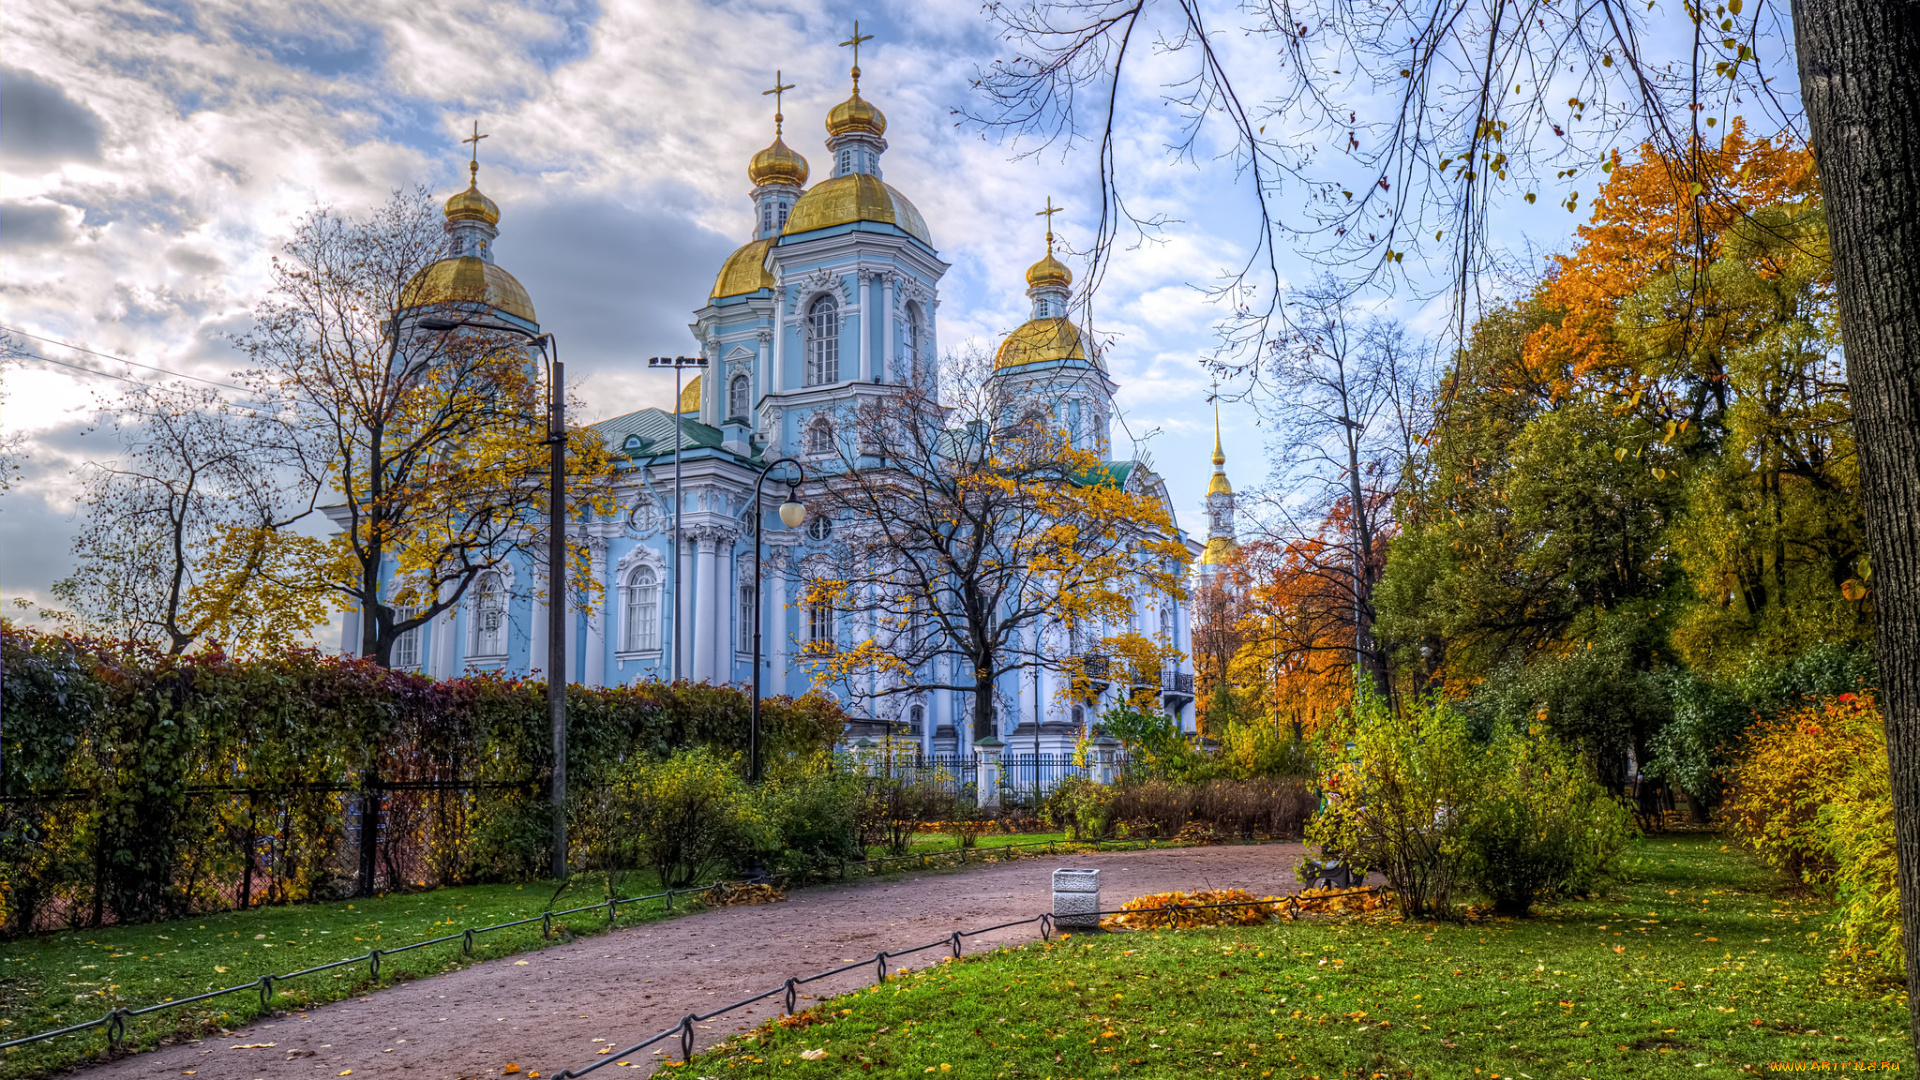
[803,357,1188,736]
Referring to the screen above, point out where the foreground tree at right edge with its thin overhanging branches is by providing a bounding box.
[979,0,1920,1022]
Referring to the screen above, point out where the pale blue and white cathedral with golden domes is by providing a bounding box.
[346,44,1233,753]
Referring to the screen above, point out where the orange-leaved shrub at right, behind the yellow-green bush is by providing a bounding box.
[1724,694,1887,884]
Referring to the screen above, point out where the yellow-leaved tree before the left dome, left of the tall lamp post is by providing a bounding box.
[240,190,611,665]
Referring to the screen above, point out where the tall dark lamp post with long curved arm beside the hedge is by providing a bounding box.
[419,317,566,878]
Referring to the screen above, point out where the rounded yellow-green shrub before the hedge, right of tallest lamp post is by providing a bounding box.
[611,749,780,888]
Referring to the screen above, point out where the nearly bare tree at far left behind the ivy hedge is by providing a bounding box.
[54,384,328,655]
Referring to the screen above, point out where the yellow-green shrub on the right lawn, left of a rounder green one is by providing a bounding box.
[1308,694,1486,917]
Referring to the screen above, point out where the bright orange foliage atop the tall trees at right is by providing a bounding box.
[1513,121,1818,396]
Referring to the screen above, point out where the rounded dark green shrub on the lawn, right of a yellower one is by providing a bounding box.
[1461,718,1634,915]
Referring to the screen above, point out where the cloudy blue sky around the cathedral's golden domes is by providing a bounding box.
[0,0,1758,630]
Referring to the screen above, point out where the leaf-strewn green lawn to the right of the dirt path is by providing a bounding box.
[685,836,1912,1080]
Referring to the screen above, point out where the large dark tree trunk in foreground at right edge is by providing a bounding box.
[1793,0,1920,1045]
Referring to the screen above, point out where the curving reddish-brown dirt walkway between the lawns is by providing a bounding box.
[86,844,1302,1080]
